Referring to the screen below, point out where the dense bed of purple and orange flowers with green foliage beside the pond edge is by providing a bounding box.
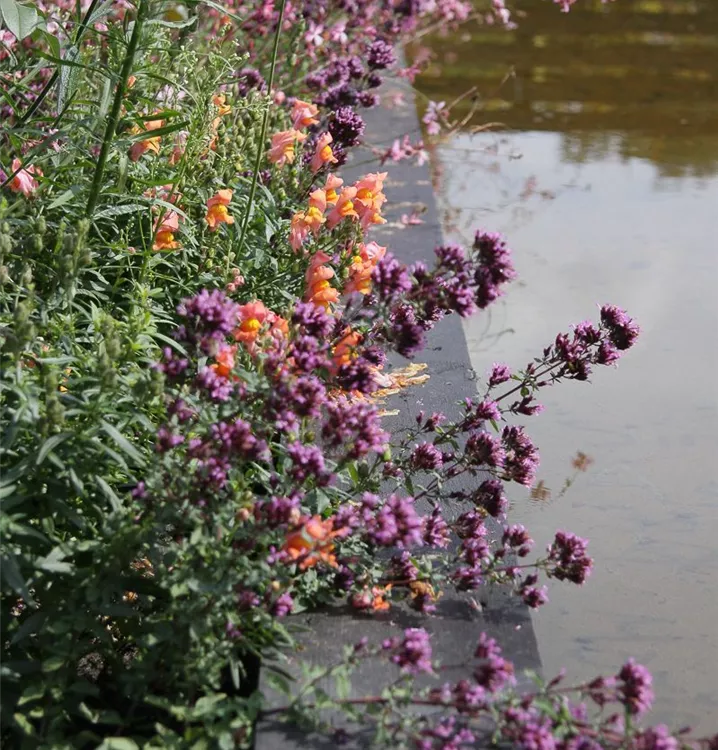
[0,0,704,748]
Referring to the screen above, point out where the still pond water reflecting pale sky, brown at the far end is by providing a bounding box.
[417,0,718,733]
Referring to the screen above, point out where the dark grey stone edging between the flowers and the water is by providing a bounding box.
[255,79,540,750]
